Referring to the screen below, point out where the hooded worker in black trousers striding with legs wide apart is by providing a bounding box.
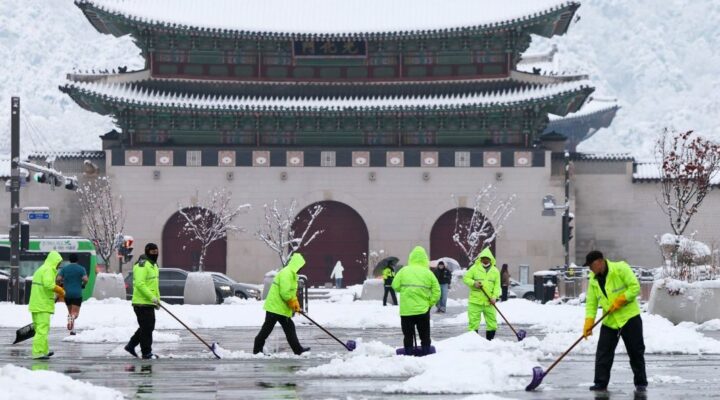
[253,253,310,355]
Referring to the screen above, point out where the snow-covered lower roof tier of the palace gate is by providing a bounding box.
[61,81,593,111]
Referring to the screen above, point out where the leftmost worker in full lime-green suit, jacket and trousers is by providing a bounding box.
[28,250,65,360]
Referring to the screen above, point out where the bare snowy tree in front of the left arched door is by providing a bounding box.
[178,188,250,272]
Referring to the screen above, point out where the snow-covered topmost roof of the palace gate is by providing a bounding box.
[75,0,580,39]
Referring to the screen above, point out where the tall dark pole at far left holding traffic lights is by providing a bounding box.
[8,97,20,304]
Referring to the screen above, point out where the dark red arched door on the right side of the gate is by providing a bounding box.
[430,207,495,268]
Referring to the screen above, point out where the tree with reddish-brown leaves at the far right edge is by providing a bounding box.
[656,129,720,235]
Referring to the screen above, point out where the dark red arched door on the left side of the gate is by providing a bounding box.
[160,208,227,273]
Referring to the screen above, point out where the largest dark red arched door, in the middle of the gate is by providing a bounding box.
[293,201,369,286]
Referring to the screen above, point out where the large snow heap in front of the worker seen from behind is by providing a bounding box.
[298,332,539,394]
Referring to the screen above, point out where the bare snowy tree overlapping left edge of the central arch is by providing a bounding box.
[255,199,323,265]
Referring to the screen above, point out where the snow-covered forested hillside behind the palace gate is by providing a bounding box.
[0,0,720,158]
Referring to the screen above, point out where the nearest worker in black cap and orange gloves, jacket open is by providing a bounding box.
[583,250,647,392]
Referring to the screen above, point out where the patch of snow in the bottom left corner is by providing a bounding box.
[0,364,123,400]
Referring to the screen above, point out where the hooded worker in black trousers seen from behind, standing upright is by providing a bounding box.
[392,246,440,356]
